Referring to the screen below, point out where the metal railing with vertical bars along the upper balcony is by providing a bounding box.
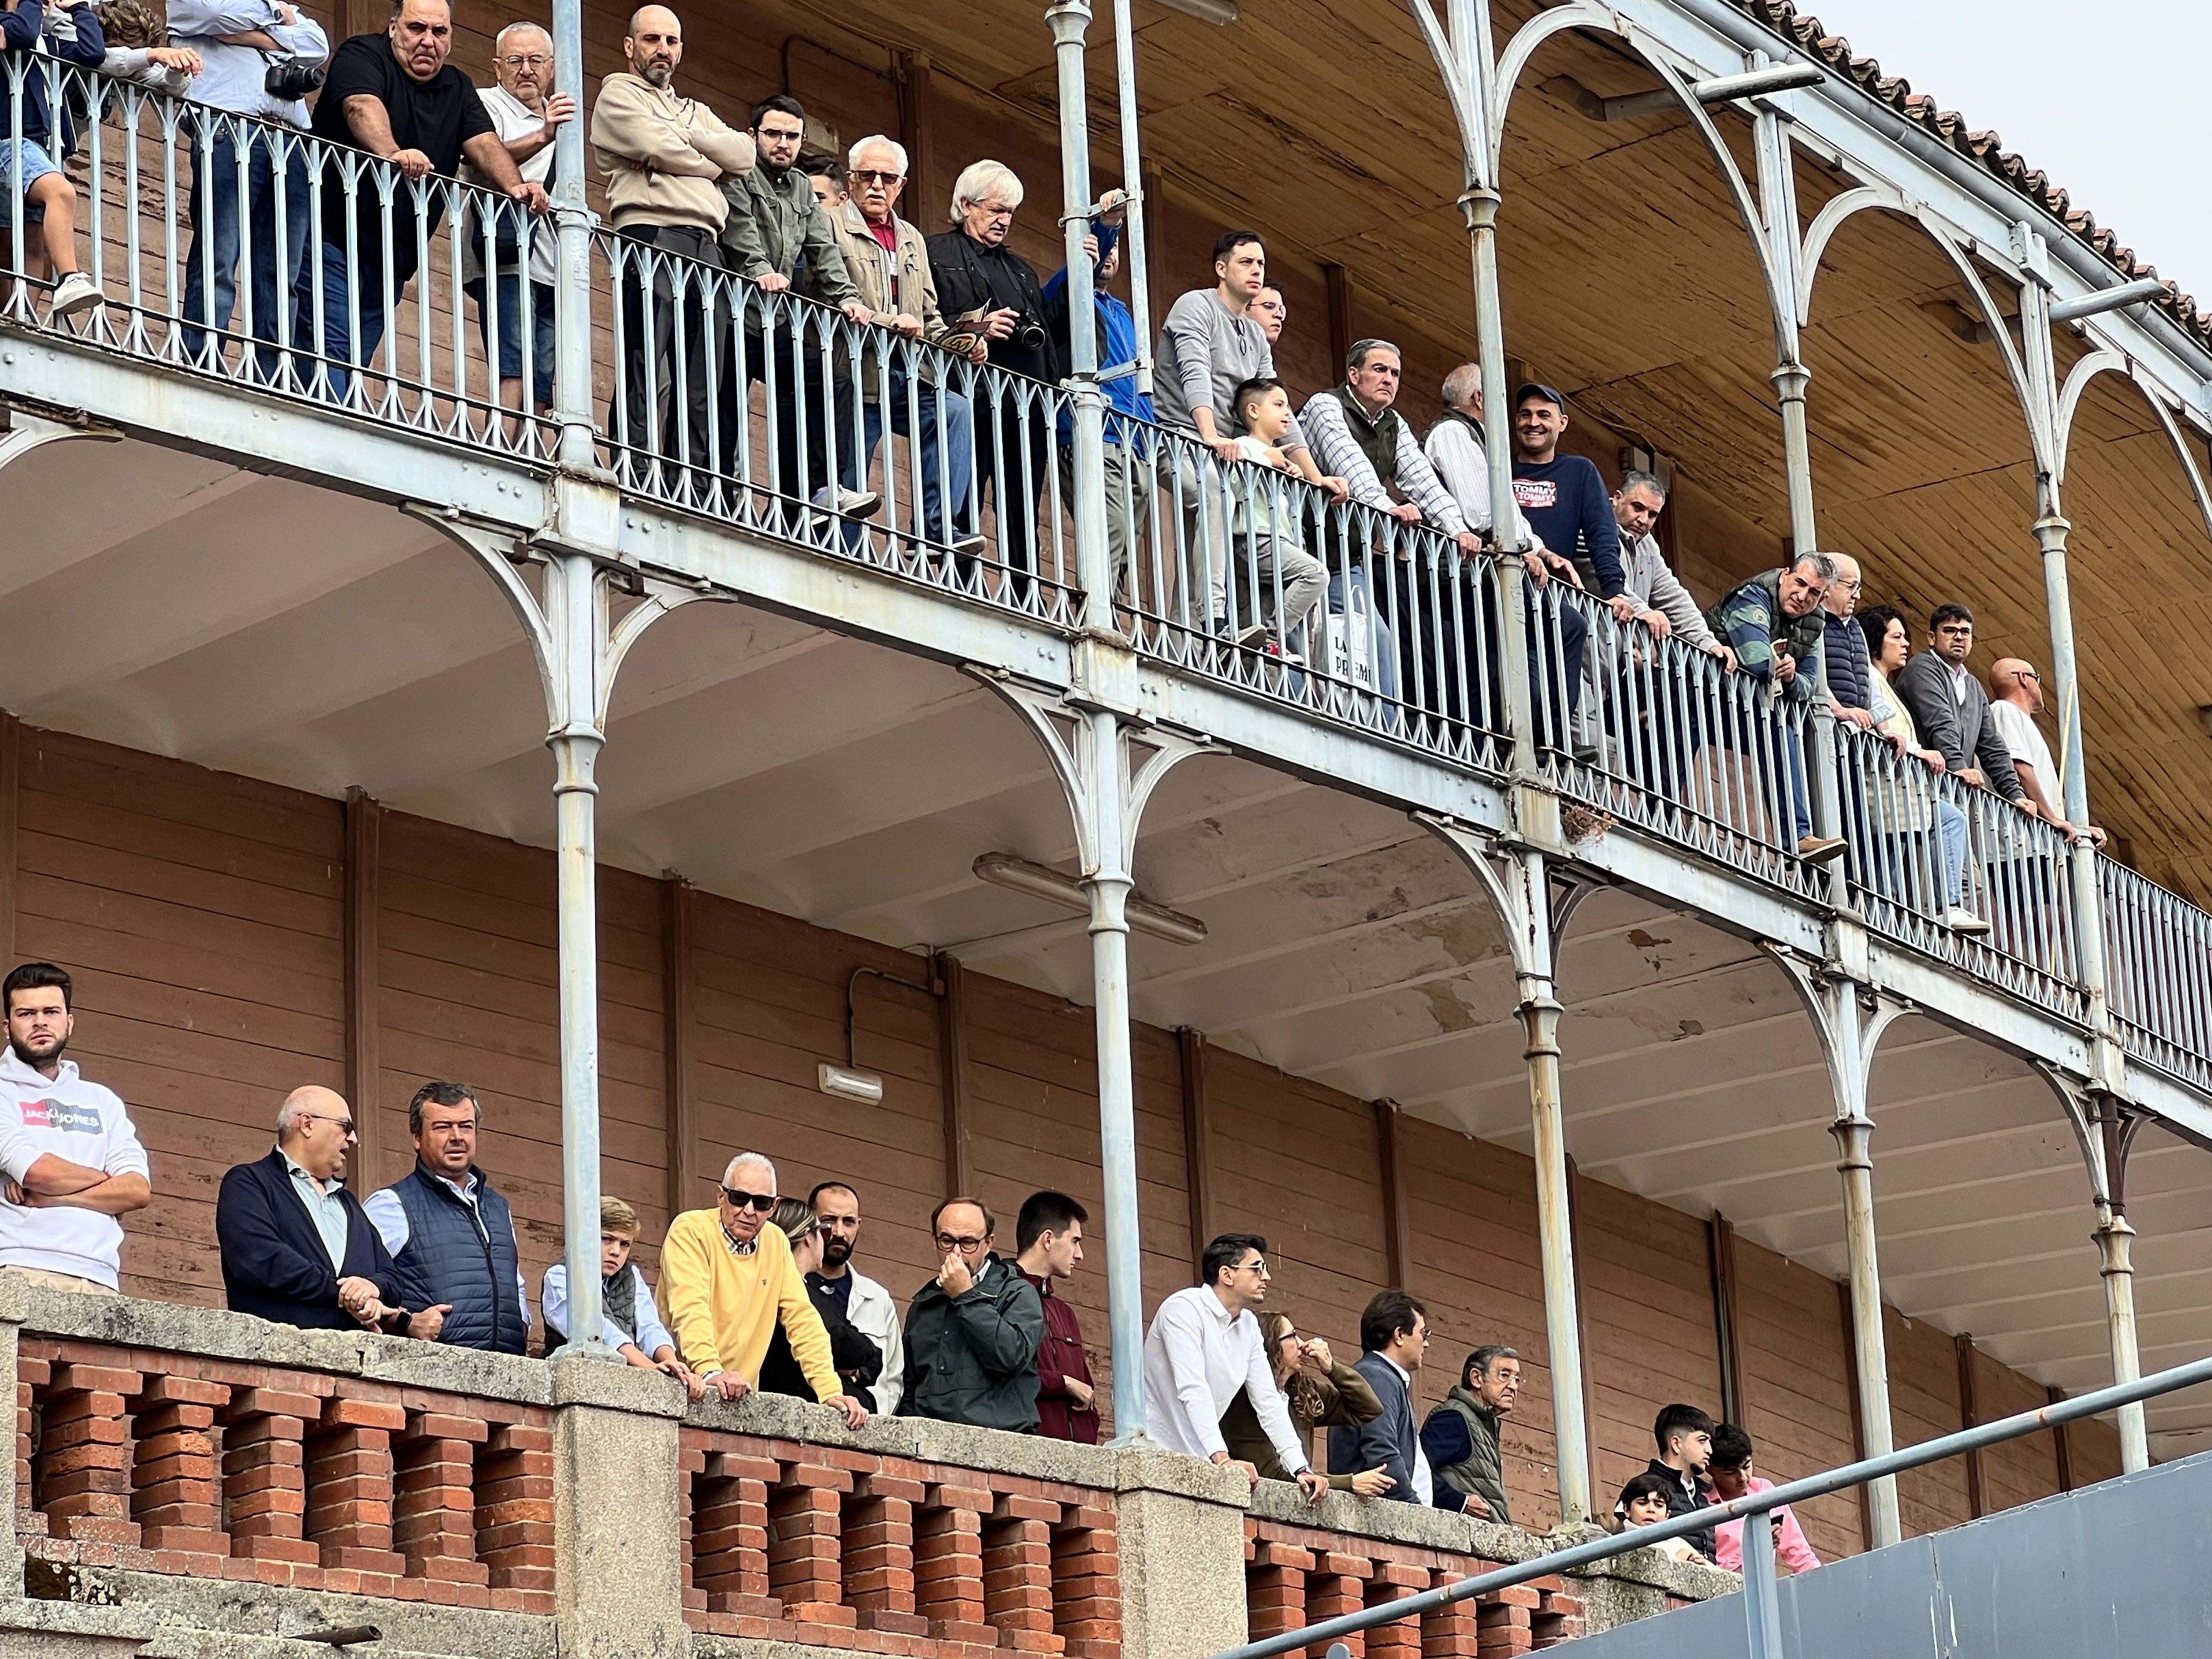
[13,53,2212,1088]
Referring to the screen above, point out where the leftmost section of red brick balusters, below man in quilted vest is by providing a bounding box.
[15,1331,553,1612]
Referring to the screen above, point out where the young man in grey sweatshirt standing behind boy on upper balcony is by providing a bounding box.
[1153,230,1347,630]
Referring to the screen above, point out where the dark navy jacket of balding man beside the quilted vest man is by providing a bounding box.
[215,1148,416,1331]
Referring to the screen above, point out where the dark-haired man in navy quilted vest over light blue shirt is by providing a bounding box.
[363,1082,531,1354]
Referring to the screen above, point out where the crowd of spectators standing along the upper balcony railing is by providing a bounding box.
[0,0,2103,911]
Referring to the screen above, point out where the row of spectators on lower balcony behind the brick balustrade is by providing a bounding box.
[0,962,1818,1571]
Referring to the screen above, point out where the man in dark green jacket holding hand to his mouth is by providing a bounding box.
[898,1199,1044,1434]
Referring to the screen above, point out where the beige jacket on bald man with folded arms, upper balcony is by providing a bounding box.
[591,71,752,236]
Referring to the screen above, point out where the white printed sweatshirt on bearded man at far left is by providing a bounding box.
[0,1048,148,1290]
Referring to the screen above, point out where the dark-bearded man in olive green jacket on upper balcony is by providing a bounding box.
[721,93,883,517]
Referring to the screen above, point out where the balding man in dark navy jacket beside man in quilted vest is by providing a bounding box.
[215,1084,449,1340]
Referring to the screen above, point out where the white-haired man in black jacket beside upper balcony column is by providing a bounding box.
[929,161,1059,600]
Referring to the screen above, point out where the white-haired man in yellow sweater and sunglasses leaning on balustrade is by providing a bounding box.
[662,1153,867,1429]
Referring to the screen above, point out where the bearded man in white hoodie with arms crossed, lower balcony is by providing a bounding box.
[0,962,153,1294]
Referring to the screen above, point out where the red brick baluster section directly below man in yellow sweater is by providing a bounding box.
[681,1429,1121,1659]
